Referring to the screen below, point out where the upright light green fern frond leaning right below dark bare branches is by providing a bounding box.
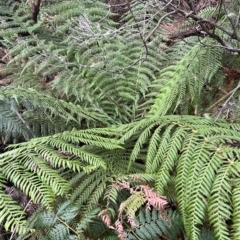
[149,37,222,117]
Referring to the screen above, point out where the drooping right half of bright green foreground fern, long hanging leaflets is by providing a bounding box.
[119,116,240,239]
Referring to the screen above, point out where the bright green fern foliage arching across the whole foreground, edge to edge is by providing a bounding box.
[1,116,240,239]
